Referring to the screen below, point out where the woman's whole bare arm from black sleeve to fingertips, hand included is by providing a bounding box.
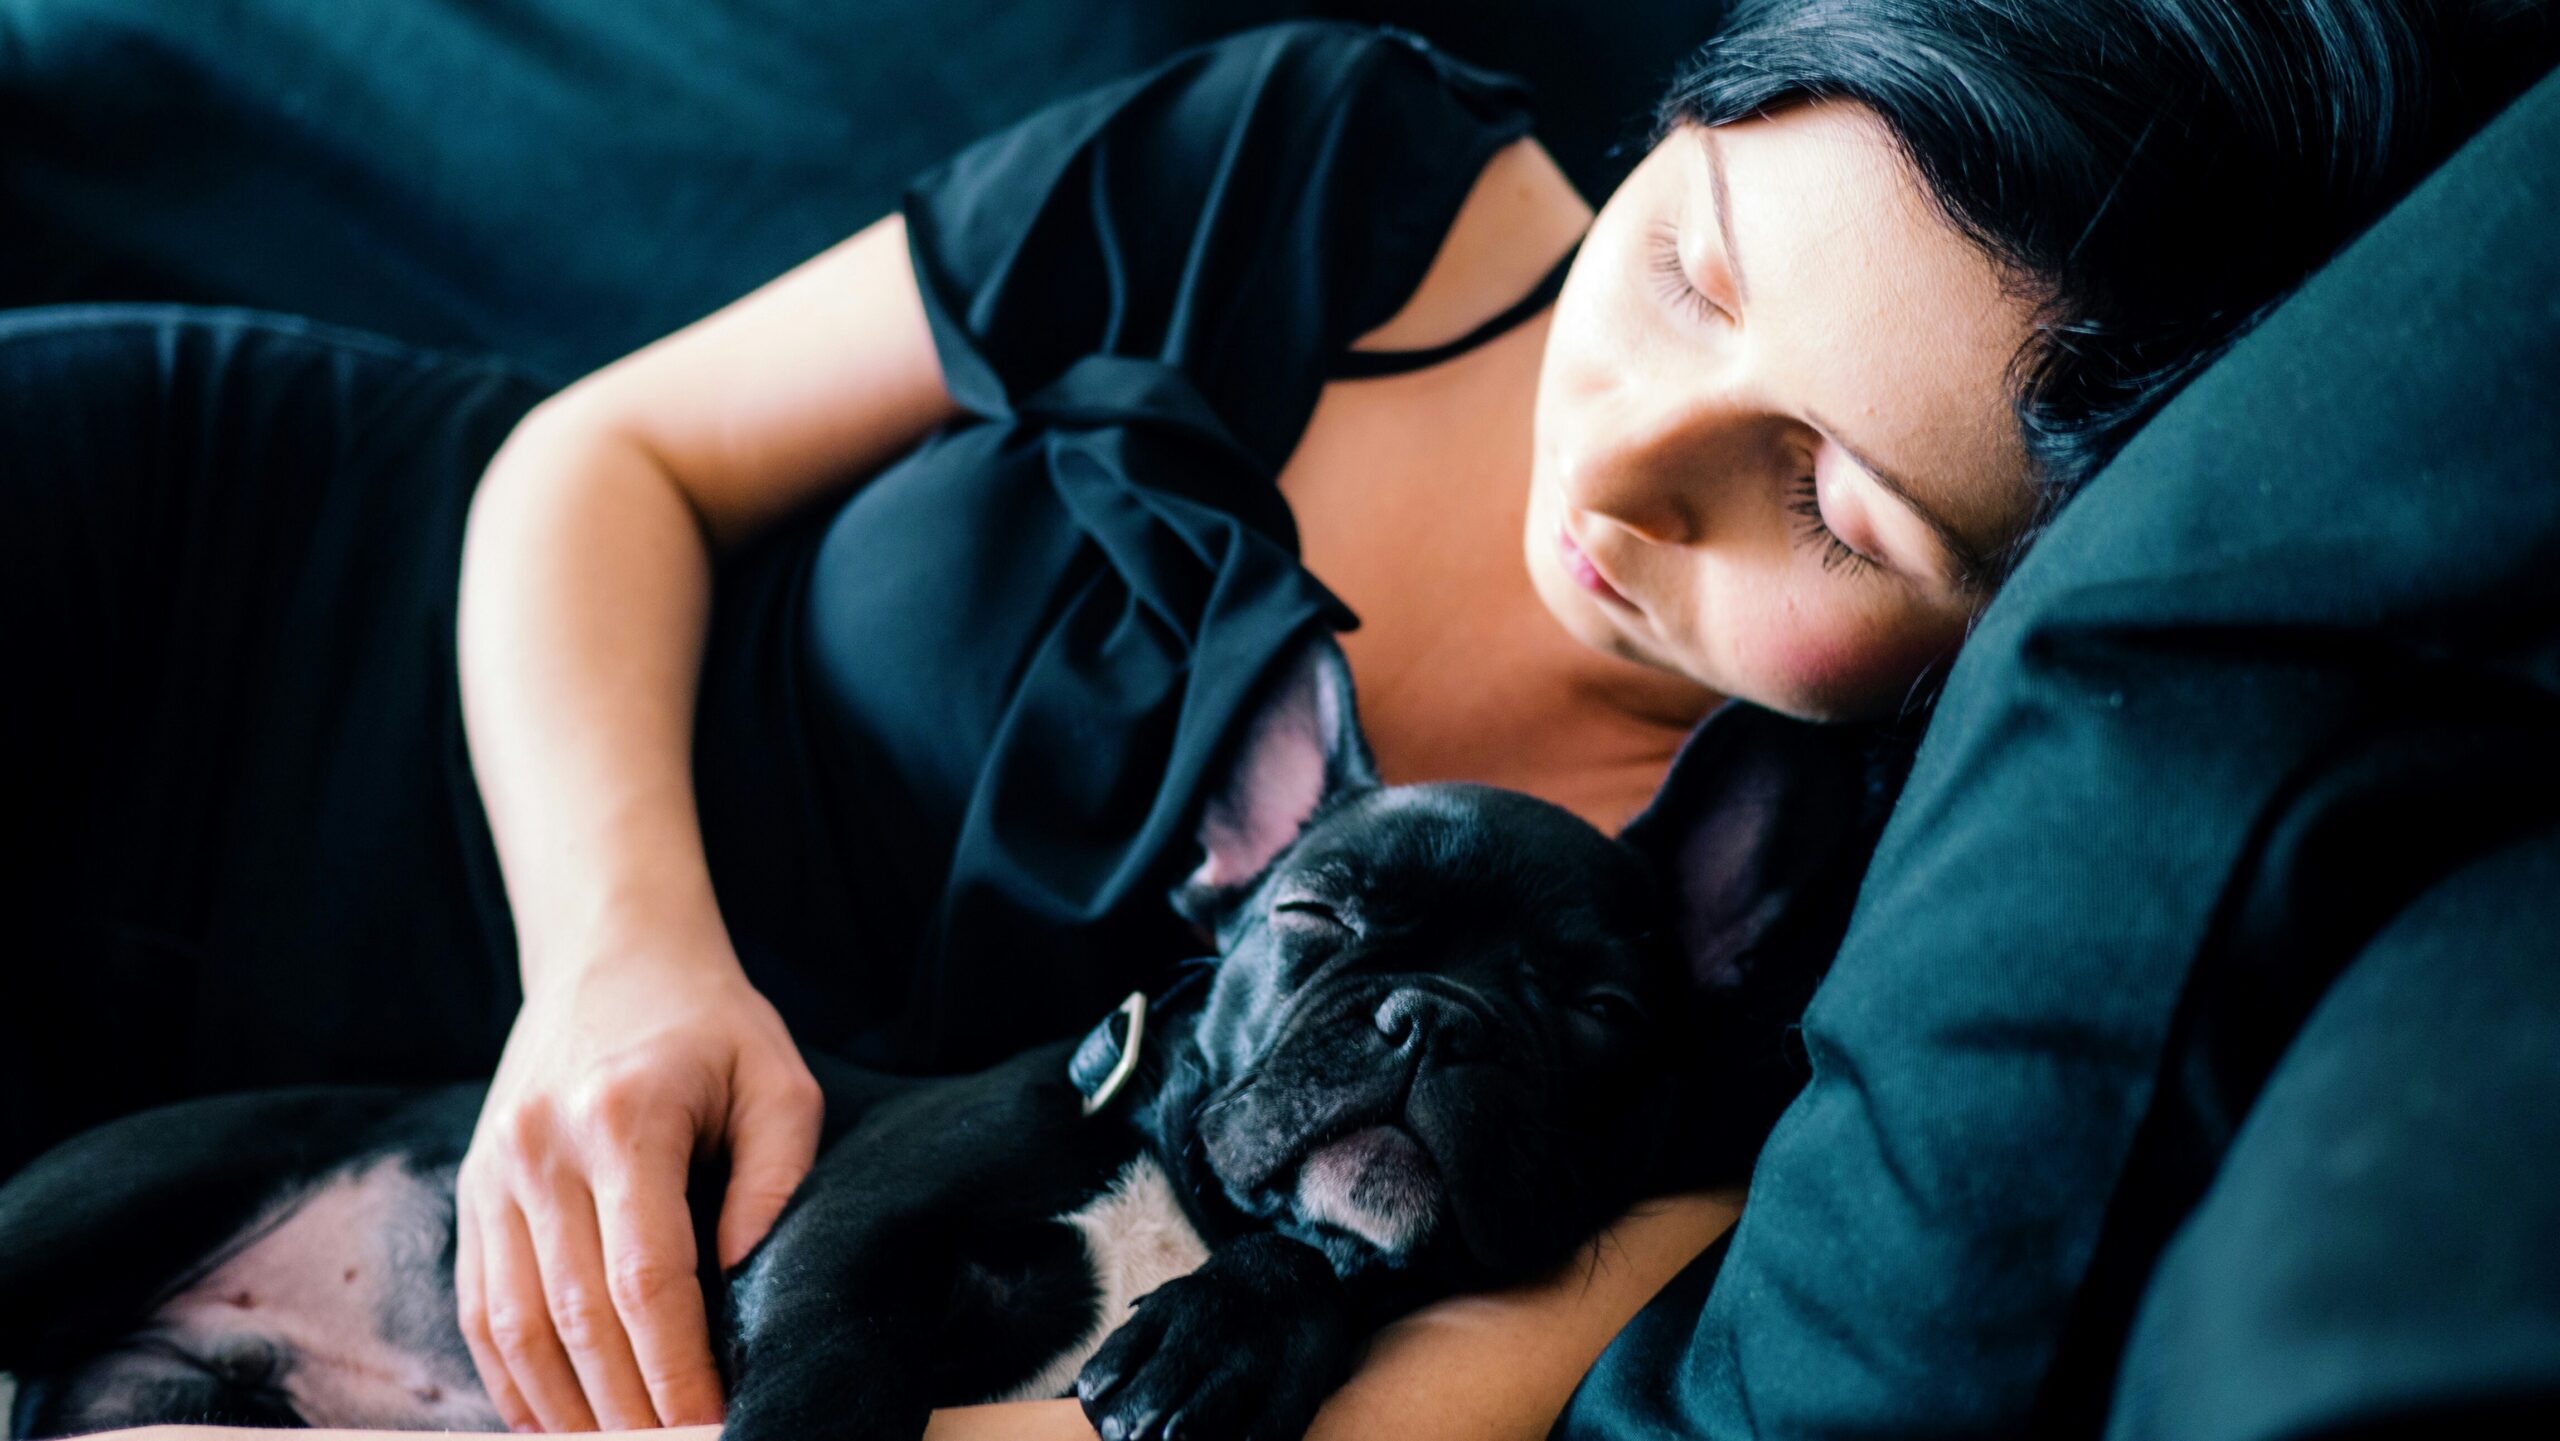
[456,218,955,1431]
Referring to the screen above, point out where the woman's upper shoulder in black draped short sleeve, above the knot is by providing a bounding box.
[901,20,1580,427]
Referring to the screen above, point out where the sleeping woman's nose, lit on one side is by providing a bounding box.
[1554,381,1748,545]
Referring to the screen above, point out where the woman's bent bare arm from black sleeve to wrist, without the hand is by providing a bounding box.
[461,215,955,973]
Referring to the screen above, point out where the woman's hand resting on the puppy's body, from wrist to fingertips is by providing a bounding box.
[453,950,822,1431]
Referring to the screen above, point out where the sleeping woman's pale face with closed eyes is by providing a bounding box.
[1526,102,2033,719]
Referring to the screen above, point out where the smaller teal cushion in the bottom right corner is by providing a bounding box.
[2109,829,2560,1441]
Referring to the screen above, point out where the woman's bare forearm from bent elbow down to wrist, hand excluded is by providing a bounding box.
[458,412,727,988]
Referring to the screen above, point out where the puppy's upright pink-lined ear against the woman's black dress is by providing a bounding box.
[1172,632,1377,927]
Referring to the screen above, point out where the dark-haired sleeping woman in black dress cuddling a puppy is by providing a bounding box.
[0,0,2534,1436]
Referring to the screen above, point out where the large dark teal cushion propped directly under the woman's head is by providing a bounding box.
[1564,59,2560,1438]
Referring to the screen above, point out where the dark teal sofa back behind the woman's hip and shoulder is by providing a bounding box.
[0,0,1718,379]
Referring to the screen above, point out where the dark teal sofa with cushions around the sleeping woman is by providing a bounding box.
[0,0,2560,1441]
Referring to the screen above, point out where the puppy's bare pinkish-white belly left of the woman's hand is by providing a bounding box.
[146,1157,504,1431]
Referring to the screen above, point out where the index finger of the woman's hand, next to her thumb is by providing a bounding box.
[596,1134,719,1426]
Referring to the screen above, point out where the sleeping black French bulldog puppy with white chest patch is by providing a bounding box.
[0,642,1682,1441]
